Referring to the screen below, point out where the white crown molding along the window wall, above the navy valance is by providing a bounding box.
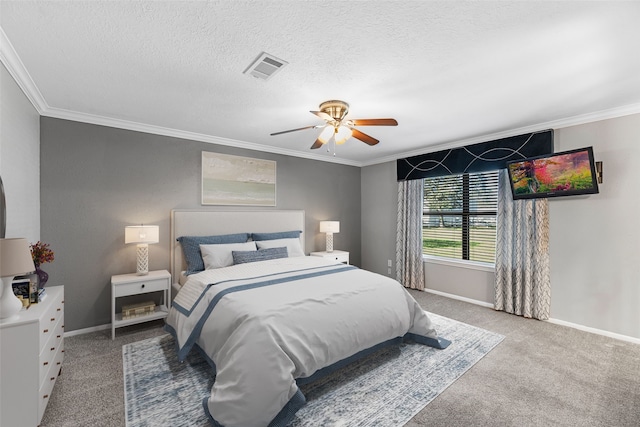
[360,104,640,167]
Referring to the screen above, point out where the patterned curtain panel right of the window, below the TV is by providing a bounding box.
[495,169,551,320]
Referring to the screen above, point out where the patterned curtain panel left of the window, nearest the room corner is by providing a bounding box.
[396,179,424,290]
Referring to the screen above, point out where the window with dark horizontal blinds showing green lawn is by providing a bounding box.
[422,171,498,263]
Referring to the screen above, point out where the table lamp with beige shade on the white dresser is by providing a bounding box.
[0,239,35,320]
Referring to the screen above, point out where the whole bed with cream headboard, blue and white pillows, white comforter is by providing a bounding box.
[165,210,449,427]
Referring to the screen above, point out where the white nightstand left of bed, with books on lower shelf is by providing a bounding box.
[111,270,171,339]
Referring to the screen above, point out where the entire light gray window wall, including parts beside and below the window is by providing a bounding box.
[361,114,640,339]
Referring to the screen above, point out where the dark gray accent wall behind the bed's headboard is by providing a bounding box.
[40,117,361,331]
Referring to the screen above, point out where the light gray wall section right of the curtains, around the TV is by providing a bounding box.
[549,114,640,338]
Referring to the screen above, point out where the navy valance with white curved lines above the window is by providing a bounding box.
[397,129,553,181]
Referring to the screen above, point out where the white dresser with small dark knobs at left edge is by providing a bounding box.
[0,286,64,427]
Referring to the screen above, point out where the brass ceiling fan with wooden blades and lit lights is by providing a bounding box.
[271,100,398,150]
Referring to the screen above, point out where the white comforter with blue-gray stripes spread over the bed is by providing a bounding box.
[167,257,448,427]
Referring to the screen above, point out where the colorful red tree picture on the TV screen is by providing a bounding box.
[509,150,593,194]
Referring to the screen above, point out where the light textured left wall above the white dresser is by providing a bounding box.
[0,64,40,242]
